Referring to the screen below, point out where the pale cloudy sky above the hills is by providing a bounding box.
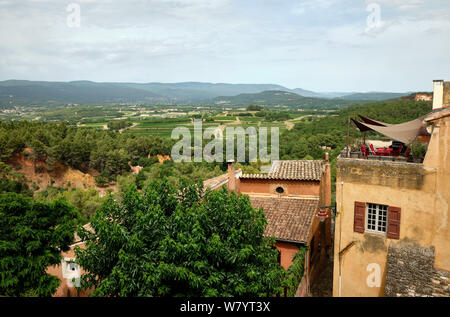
[0,0,450,91]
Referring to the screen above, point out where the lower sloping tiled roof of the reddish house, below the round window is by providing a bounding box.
[250,196,319,243]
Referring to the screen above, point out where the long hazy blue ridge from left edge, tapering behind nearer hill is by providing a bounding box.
[0,80,289,105]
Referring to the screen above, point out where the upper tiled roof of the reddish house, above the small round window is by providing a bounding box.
[240,160,323,181]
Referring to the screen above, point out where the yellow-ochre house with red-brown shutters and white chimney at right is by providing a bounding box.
[333,81,450,297]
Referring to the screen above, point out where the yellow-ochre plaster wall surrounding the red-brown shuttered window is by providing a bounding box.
[333,117,450,296]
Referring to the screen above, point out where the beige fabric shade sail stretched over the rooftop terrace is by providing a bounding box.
[352,116,429,144]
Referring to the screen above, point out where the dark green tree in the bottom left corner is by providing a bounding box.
[0,193,78,296]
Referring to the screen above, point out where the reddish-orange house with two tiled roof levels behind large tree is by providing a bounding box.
[204,154,332,296]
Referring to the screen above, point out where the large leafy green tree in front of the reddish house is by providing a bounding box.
[75,180,284,297]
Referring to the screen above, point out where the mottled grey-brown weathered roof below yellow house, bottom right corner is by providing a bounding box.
[385,243,450,297]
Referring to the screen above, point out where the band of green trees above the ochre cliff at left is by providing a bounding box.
[0,121,173,177]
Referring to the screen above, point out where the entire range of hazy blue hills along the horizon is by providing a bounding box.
[0,80,410,107]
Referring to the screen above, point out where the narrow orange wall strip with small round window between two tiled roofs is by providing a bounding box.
[240,178,320,196]
